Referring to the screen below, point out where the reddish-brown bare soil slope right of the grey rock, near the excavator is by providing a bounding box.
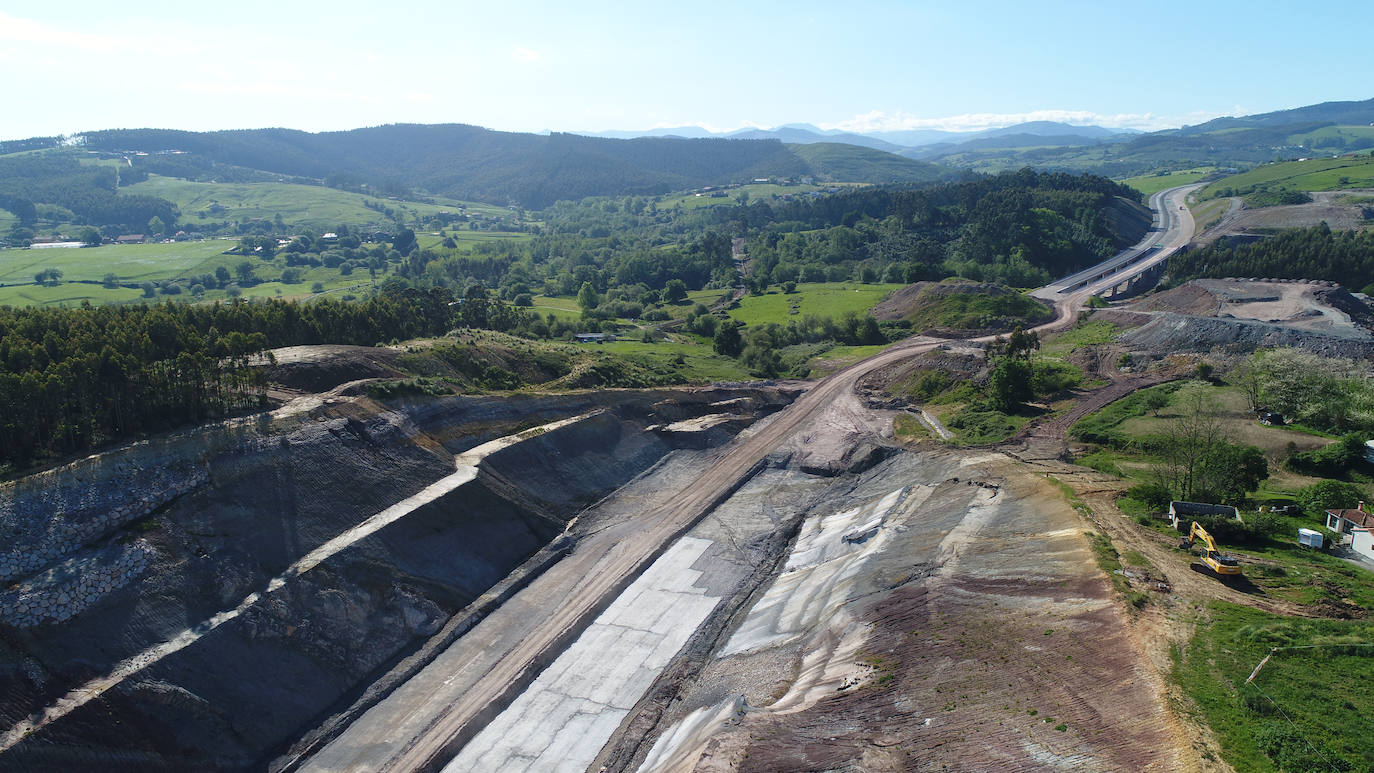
[697,478,1204,772]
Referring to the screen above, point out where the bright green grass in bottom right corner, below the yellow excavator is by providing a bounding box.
[1173,604,1374,773]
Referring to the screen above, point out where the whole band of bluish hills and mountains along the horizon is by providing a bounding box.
[0,99,1374,225]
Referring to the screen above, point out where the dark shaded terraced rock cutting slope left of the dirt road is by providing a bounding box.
[0,389,793,770]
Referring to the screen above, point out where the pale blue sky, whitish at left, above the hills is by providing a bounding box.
[0,0,1374,139]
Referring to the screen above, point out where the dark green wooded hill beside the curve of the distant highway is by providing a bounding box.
[717,169,1150,287]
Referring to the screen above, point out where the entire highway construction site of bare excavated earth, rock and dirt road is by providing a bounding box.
[0,183,1374,773]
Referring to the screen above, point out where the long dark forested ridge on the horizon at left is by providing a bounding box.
[48,124,948,209]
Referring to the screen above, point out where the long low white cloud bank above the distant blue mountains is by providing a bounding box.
[820,110,1226,132]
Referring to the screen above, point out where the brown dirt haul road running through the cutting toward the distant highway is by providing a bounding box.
[301,183,1193,770]
